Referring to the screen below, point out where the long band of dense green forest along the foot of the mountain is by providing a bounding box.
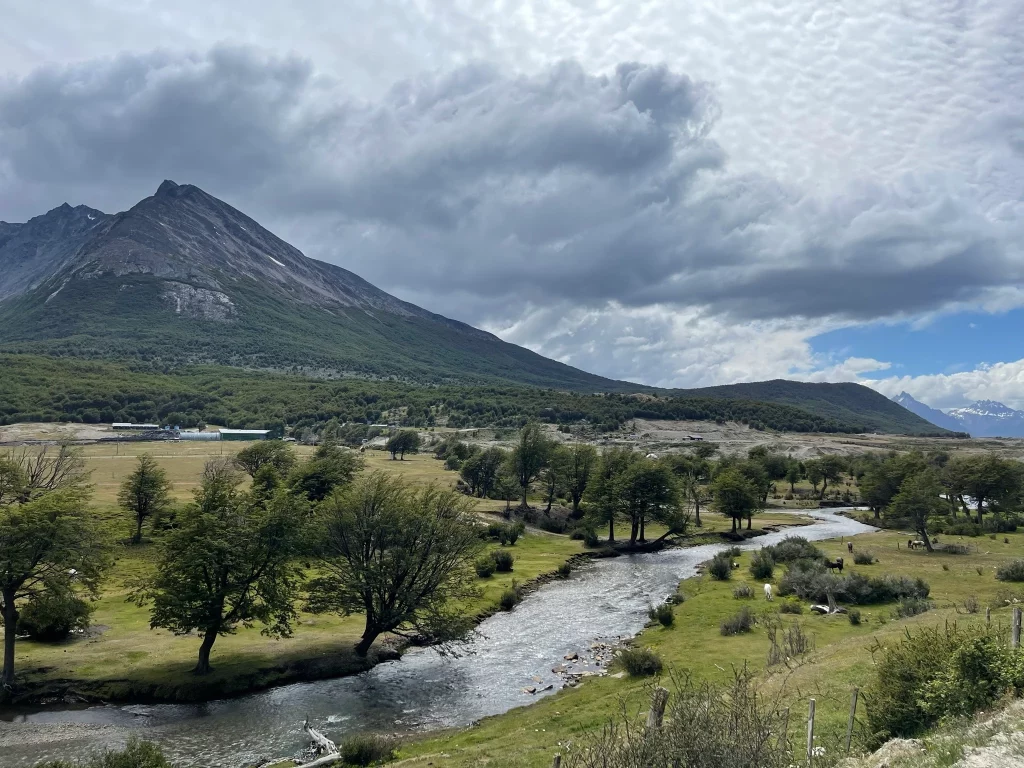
[0,355,864,432]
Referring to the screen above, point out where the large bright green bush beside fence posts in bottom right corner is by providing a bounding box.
[867,624,1024,742]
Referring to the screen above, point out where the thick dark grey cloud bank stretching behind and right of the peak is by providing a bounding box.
[0,47,1024,323]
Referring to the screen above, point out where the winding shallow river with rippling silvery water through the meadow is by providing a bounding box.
[0,510,872,768]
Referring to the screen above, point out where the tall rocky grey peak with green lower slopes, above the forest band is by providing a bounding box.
[0,181,645,391]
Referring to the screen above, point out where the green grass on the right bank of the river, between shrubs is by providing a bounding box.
[393,528,1024,768]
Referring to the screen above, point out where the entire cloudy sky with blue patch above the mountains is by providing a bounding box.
[0,0,1024,408]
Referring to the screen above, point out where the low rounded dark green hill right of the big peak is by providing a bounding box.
[687,379,947,435]
